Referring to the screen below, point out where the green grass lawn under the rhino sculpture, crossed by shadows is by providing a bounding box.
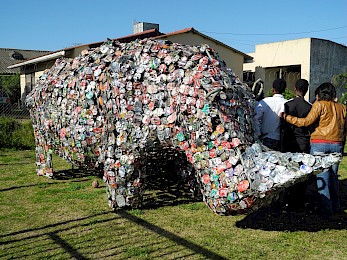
[0,151,347,259]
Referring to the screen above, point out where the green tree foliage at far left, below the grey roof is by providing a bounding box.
[0,74,21,103]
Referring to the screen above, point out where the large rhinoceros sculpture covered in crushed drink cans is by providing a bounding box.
[26,39,340,215]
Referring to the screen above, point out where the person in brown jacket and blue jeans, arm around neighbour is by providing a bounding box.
[282,82,347,218]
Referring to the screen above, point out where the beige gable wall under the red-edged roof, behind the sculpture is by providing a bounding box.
[167,32,244,80]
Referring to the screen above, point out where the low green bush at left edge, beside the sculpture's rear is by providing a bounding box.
[0,117,35,150]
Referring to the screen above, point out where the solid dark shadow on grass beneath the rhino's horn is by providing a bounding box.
[236,179,347,232]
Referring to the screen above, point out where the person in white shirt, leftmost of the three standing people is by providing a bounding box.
[255,79,287,151]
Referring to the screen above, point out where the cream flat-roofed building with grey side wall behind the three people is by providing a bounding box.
[243,38,347,101]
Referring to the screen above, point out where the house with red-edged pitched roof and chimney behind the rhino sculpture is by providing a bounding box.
[8,23,253,103]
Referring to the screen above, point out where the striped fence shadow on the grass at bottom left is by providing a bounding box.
[0,210,226,259]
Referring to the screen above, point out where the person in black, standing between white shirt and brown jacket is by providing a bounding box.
[281,79,312,211]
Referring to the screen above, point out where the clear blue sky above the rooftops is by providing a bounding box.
[0,0,347,53]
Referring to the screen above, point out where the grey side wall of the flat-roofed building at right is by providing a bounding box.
[310,38,347,101]
